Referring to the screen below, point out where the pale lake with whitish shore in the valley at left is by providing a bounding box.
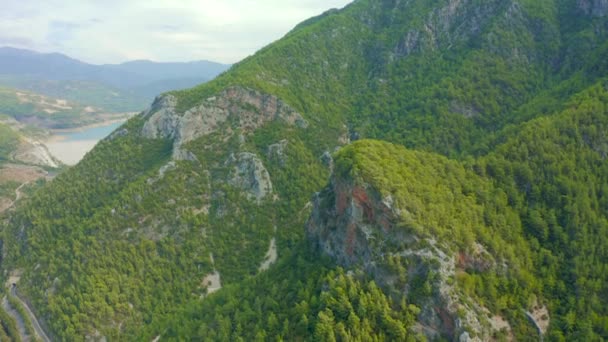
[46,121,124,165]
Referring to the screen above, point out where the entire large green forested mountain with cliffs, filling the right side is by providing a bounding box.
[1,0,608,341]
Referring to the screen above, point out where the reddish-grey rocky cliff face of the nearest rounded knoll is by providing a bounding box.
[306,177,510,341]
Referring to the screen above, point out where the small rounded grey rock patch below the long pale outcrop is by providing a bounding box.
[225,152,272,203]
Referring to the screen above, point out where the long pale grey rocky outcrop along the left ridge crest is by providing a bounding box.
[141,87,308,160]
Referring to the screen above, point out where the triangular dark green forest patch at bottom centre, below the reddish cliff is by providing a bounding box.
[138,246,421,341]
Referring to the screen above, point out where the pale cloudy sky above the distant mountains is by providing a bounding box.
[0,0,351,64]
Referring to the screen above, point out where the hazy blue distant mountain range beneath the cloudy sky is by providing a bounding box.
[0,47,230,112]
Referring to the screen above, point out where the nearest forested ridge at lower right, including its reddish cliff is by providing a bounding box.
[151,81,608,340]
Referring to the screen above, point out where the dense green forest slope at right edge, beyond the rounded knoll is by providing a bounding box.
[475,82,608,341]
